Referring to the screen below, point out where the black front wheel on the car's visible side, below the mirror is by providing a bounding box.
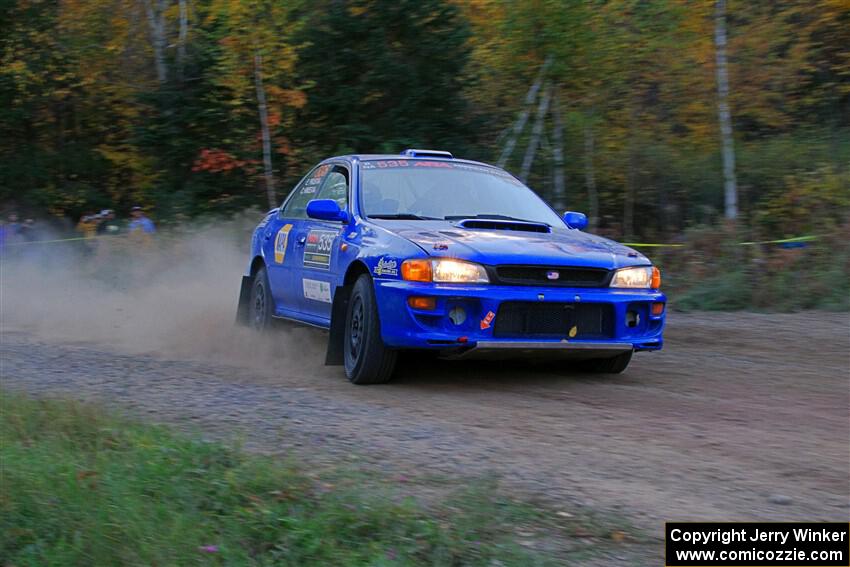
[343,274,398,384]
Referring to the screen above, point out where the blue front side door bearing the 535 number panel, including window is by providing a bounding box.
[296,164,351,324]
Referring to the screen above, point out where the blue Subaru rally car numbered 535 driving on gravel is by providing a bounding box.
[237,150,666,384]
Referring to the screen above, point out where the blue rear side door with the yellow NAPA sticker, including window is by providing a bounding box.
[263,166,330,317]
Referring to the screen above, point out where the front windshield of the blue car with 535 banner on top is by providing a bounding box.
[361,159,562,226]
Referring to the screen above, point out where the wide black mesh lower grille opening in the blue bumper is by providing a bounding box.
[493,301,614,339]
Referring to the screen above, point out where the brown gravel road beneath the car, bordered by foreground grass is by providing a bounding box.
[0,312,850,535]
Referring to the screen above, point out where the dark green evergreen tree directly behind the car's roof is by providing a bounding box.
[298,0,473,155]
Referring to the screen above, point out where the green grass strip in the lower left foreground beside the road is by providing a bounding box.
[0,392,633,566]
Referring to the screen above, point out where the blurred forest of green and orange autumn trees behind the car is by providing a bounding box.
[0,0,850,240]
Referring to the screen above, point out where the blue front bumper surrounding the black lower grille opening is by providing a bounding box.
[375,279,667,356]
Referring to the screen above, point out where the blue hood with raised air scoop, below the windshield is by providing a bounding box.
[376,220,650,269]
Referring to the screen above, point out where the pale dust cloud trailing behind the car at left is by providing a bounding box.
[0,216,326,370]
